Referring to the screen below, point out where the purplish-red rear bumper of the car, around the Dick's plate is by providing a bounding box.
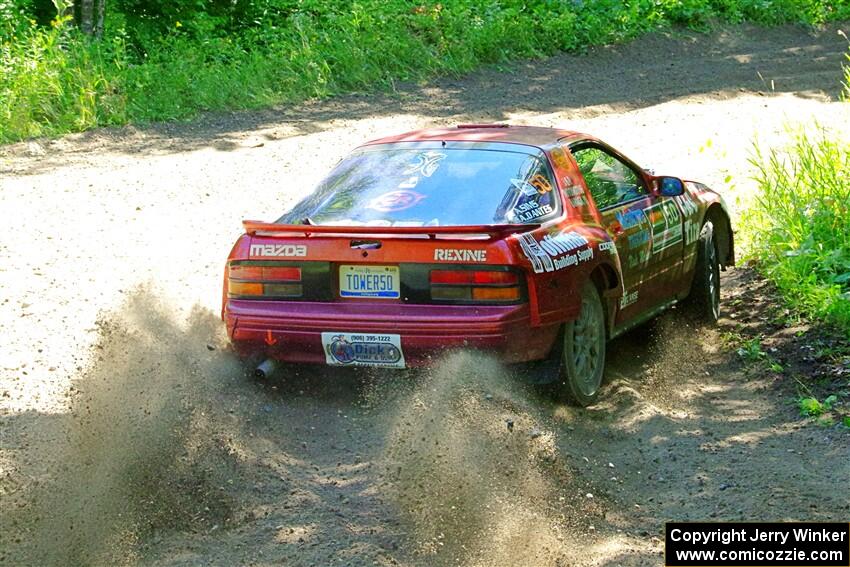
[224,300,558,366]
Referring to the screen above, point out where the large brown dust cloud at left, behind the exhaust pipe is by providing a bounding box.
[0,288,247,566]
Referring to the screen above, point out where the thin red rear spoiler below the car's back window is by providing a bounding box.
[242,220,540,238]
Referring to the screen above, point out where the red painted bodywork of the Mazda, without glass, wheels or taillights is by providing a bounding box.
[222,126,734,366]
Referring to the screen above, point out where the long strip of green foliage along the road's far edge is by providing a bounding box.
[0,0,850,142]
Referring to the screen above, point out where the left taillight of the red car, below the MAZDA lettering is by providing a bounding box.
[227,262,304,298]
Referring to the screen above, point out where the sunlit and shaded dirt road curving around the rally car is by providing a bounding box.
[0,22,850,566]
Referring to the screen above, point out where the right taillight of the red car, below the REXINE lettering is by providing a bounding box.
[430,270,522,303]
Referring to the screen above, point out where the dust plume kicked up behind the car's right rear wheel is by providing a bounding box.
[378,353,601,566]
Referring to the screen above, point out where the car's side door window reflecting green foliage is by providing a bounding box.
[572,146,649,210]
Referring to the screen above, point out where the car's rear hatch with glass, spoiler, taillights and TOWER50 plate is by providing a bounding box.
[228,141,562,305]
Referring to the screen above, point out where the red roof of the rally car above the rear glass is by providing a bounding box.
[364,124,593,149]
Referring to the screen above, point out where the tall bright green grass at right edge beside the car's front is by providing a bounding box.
[741,133,850,334]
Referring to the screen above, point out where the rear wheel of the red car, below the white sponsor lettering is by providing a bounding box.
[558,281,606,407]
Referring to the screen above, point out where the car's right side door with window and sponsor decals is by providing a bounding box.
[570,141,682,325]
